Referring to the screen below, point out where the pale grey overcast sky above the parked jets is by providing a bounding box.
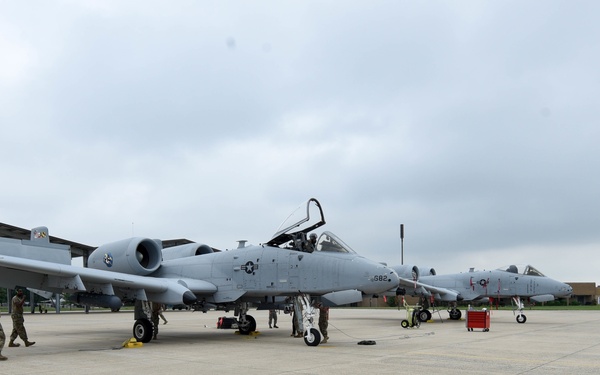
[0,0,600,282]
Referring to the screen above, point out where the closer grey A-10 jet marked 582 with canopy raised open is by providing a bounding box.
[0,198,399,346]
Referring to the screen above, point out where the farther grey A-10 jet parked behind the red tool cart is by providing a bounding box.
[391,265,573,323]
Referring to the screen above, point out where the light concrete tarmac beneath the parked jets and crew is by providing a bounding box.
[0,308,600,375]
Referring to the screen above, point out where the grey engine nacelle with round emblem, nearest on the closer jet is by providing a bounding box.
[88,237,162,276]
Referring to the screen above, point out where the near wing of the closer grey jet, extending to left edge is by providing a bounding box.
[0,255,217,304]
